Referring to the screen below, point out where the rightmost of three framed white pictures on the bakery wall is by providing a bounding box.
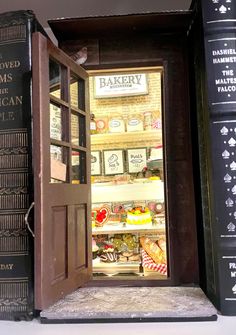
[127,148,147,173]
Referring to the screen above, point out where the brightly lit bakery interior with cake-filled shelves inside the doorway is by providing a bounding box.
[86,67,167,279]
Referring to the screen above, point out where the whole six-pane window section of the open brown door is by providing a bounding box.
[49,59,87,184]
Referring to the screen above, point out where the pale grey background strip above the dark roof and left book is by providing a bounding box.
[0,0,191,27]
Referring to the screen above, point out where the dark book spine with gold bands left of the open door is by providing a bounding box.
[0,11,34,320]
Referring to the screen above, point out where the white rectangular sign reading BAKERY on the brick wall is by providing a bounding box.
[94,73,148,98]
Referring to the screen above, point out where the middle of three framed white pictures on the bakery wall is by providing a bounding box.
[103,149,124,175]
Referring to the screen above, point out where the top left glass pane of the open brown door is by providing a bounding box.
[49,59,61,98]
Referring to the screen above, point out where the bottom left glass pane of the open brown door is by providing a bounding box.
[50,145,68,183]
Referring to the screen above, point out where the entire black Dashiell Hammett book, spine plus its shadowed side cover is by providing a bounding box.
[193,0,236,315]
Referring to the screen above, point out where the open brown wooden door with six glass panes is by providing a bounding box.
[33,33,92,309]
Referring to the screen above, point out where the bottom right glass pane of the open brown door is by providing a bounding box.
[71,150,86,184]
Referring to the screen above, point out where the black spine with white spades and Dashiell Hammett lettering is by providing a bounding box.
[201,0,236,315]
